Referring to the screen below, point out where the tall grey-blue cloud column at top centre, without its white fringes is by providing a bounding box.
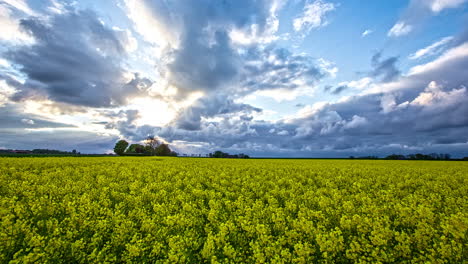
[139,0,272,93]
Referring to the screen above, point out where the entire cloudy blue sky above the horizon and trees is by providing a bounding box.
[0,0,468,157]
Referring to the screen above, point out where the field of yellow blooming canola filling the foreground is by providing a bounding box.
[0,157,468,263]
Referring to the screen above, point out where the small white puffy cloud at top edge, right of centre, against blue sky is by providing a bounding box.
[293,0,335,33]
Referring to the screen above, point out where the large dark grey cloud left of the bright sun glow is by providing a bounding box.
[5,8,151,107]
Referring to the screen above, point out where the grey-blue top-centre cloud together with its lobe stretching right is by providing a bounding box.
[137,0,323,95]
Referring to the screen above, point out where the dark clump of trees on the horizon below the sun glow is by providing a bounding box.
[114,136,177,157]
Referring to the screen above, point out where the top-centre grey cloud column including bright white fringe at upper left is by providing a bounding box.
[126,0,286,97]
